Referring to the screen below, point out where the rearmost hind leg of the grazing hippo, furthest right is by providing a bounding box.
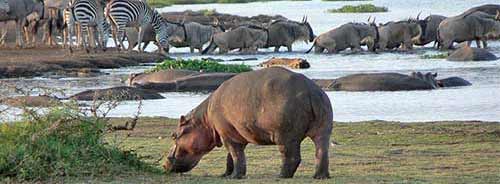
[311,136,330,179]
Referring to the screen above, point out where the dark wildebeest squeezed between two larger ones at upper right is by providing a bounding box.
[414,15,446,46]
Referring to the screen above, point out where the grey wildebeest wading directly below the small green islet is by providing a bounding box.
[307,20,379,53]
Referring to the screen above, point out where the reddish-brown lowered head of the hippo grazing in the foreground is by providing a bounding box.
[163,116,222,173]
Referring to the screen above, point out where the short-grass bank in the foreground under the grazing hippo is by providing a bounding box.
[37,117,500,183]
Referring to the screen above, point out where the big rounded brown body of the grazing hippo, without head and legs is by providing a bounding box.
[208,67,333,144]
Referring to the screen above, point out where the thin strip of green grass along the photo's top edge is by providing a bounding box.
[148,0,309,7]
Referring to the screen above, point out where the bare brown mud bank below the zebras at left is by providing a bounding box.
[0,48,165,79]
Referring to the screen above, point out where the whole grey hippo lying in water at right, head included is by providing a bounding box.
[314,72,470,91]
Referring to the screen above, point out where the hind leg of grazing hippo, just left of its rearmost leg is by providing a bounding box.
[279,141,301,178]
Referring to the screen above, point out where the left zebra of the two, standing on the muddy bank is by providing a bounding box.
[71,0,110,52]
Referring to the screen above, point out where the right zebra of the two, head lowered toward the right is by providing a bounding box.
[106,0,168,53]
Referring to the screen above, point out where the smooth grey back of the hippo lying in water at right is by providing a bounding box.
[332,73,433,91]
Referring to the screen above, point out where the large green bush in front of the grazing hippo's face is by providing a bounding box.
[0,107,153,181]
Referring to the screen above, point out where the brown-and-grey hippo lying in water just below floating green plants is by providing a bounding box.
[128,70,236,92]
